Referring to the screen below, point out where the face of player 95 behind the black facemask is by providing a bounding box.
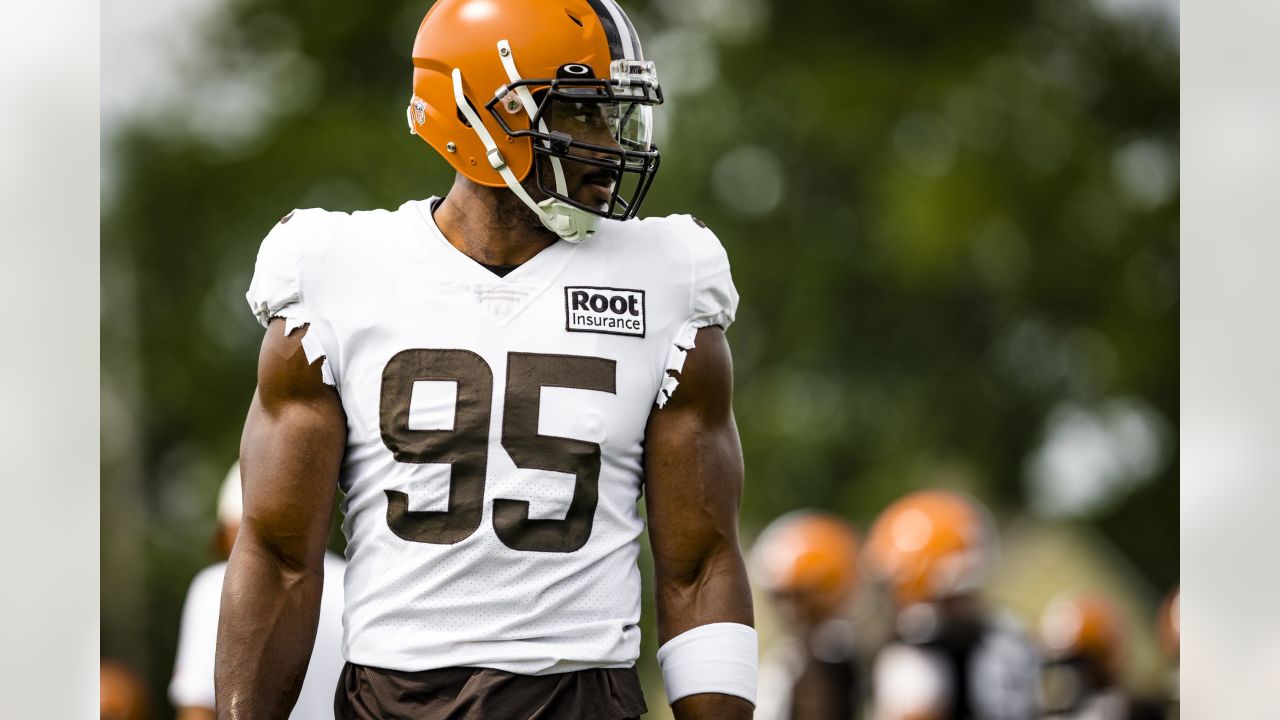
[540,100,623,208]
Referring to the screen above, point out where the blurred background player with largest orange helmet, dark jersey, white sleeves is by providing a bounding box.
[864,491,1038,720]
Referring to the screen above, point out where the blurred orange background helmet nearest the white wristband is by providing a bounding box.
[751,510,858,618]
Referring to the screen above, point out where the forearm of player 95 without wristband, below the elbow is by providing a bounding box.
[214,532,324,720]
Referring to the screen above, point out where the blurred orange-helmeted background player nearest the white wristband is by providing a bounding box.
[751,510,864,720]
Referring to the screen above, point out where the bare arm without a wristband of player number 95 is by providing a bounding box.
[215,319,346,720]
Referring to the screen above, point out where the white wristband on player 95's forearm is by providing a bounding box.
[658,623,759,705]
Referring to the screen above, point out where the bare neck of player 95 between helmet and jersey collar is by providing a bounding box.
[434,179,557,265]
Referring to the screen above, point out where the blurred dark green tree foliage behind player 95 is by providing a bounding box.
[102,0,1178,707]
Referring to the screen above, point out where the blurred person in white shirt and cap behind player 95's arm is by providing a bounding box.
[169,462,346,720]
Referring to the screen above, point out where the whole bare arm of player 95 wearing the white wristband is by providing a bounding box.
[645,327,754,720]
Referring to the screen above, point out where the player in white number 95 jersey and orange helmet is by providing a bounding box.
[218,0,756,720]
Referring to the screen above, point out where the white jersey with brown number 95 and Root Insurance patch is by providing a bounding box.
[248,199,737,675]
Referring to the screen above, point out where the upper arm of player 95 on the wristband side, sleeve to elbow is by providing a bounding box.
[645,327,742,580]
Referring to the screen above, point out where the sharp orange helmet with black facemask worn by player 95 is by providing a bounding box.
[408,0,662,241]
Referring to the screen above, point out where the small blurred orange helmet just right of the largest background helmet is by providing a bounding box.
[1039,593,1125,682]
